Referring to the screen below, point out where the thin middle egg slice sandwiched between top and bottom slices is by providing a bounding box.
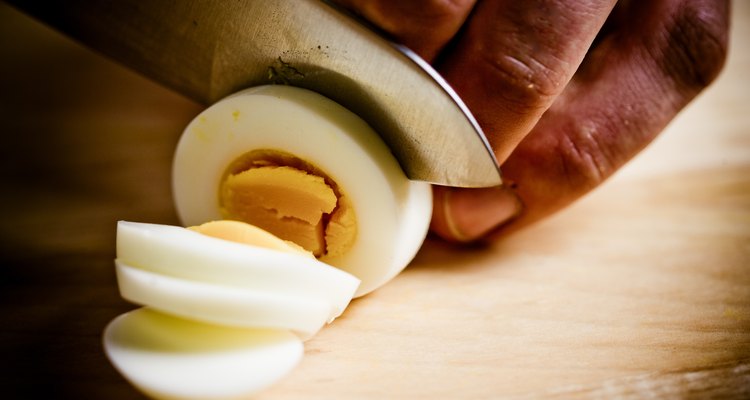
[116,261,332,339]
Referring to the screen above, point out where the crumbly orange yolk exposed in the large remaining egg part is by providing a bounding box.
[219,150,357,258]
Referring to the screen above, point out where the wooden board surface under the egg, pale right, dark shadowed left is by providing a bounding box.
[0,1,750,399]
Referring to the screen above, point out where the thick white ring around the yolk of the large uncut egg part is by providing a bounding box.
[173,86,432,295]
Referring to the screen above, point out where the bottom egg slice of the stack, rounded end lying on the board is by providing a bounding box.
[103,308,303,399]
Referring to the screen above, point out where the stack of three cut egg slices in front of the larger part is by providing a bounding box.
[104,221,359,399]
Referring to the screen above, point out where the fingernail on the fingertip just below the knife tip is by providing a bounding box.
[443,186,521,242]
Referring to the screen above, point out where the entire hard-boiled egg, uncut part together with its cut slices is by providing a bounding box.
[104,86,432,398]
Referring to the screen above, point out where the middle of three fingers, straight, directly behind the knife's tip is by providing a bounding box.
[437,0,616,162]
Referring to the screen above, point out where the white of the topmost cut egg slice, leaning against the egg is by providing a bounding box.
[117,221,359,320]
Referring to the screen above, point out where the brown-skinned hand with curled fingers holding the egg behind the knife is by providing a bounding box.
[339,0,729,241]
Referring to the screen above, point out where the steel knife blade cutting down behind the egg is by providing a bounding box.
[9,0,501,187]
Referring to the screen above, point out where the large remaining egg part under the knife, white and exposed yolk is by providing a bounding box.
[173,86,432,296]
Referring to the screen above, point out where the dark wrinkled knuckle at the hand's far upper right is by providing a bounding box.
[662,0,728,90]
